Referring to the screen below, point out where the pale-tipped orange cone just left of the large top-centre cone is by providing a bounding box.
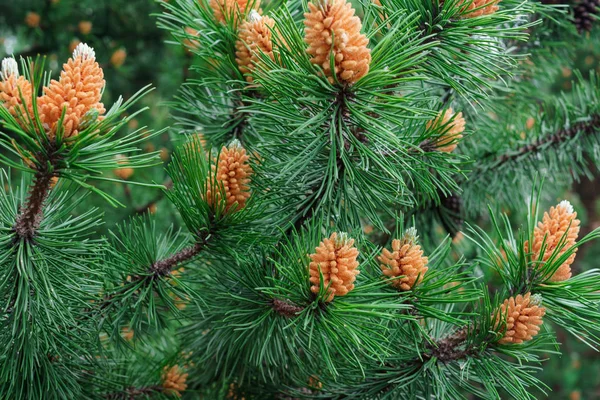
[235,10,275,83]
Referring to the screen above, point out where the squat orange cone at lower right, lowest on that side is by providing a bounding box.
[496,293,546,344]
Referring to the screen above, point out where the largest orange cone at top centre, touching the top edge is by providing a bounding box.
[304,0,371,85]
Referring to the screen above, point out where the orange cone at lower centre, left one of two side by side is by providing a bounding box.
[309,232,360,302]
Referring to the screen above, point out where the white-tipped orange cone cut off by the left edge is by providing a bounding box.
[0,57,33,123]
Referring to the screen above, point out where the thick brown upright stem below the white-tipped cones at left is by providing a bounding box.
[13,144,58,240]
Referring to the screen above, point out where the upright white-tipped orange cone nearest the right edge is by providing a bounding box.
[525,200,580,282]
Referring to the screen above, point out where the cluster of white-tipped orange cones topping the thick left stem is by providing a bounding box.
[0,43,106,139]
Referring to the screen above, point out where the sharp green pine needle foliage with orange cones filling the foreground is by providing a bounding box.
[0,0,600,400]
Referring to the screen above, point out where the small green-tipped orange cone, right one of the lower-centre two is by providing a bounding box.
[377,228,428,290]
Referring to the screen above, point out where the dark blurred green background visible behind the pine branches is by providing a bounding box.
[0,0,600,400]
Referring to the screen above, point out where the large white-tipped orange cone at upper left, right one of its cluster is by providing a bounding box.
[38,43,106,139]
